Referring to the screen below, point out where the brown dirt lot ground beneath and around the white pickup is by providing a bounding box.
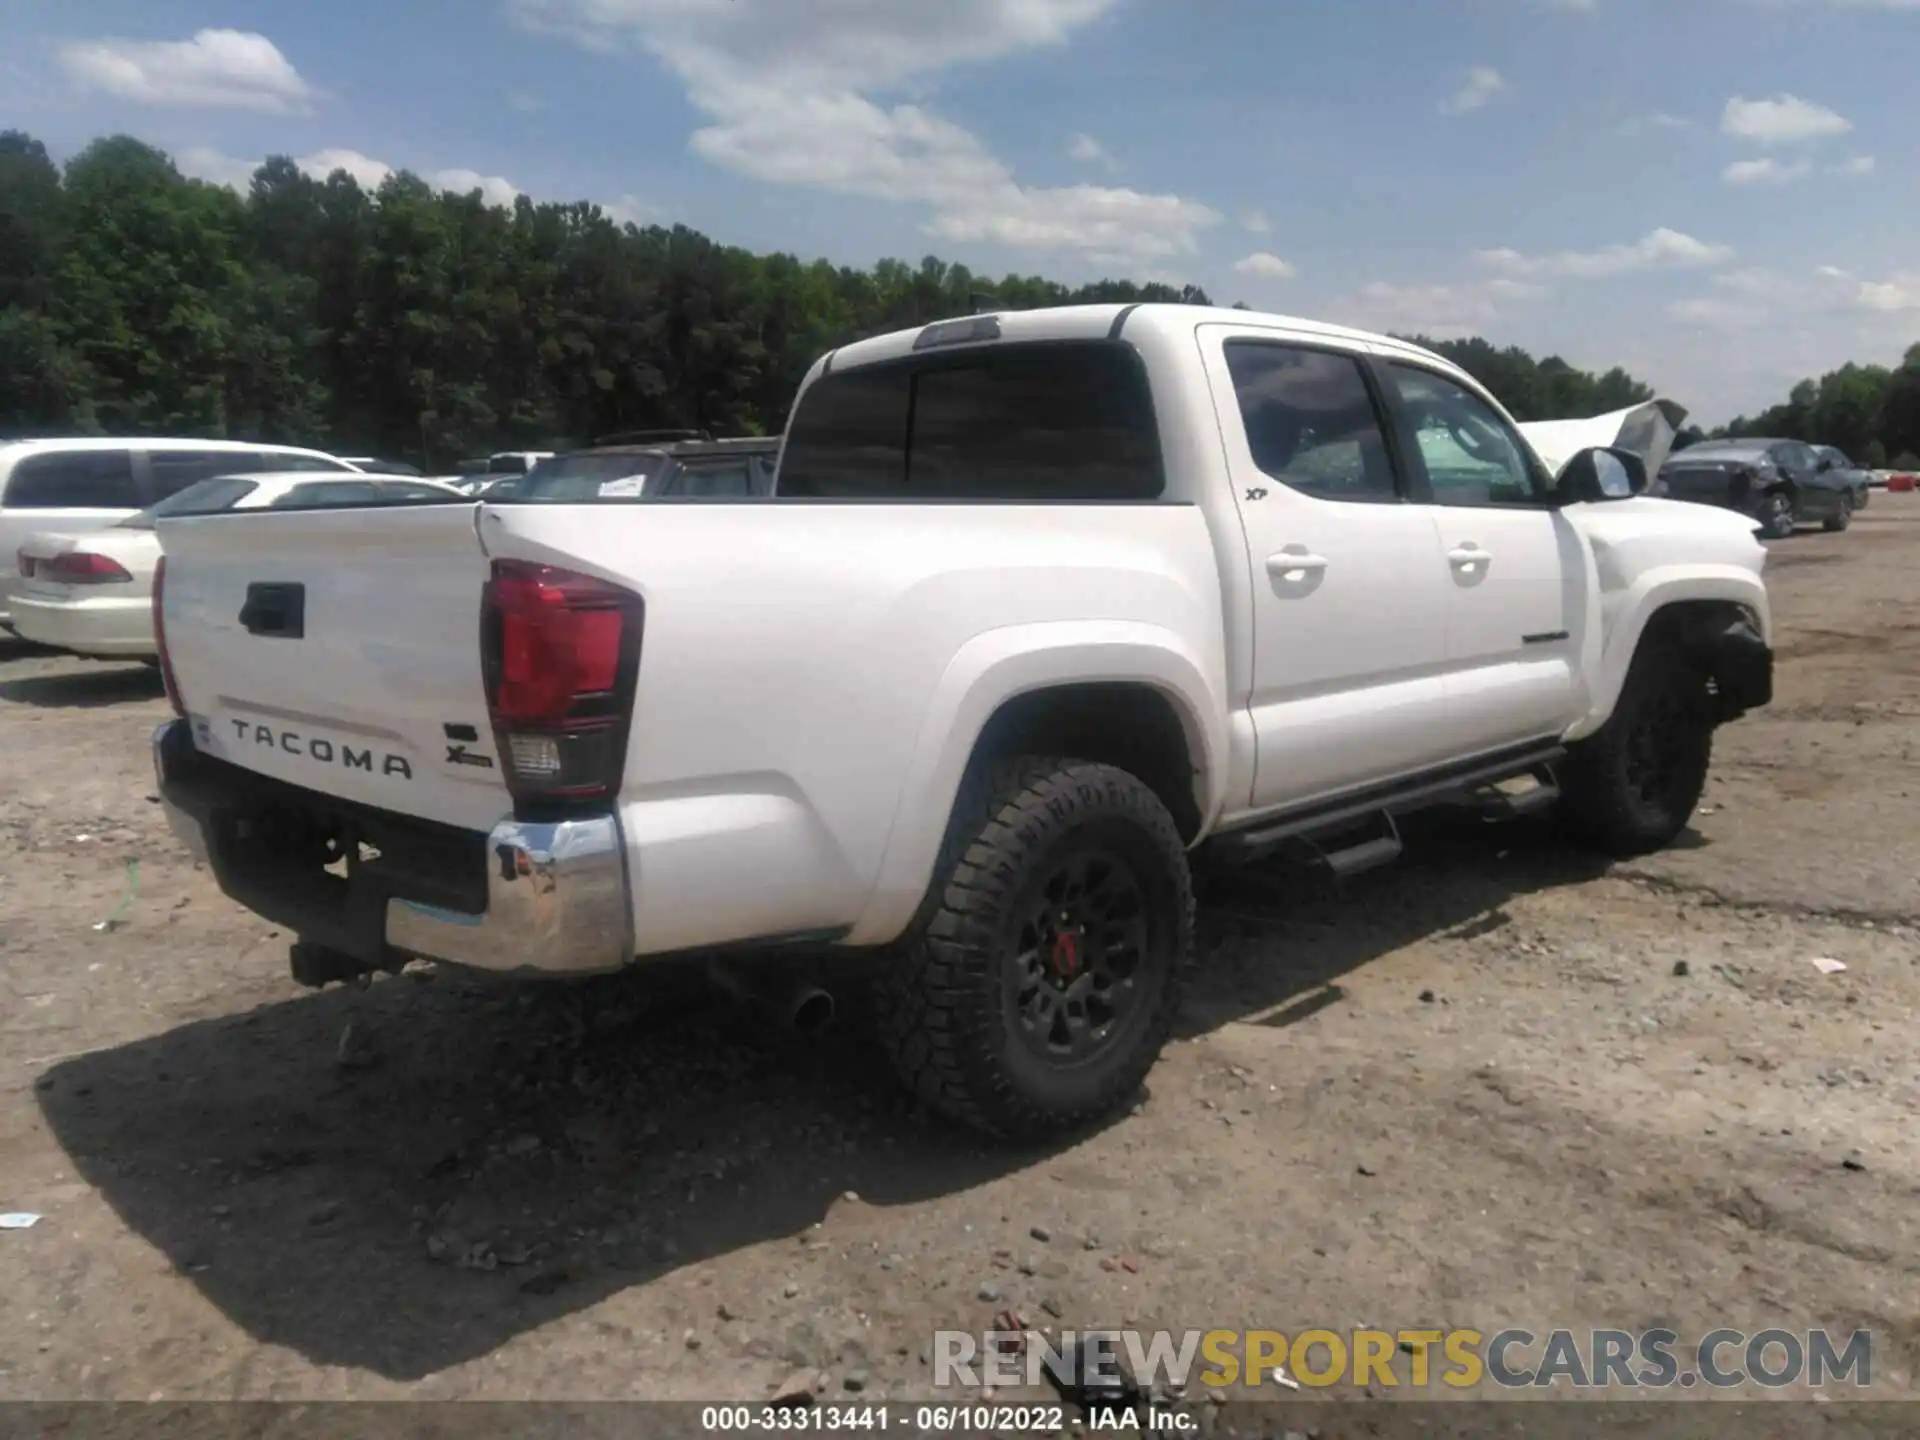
[0,493,1920,1400]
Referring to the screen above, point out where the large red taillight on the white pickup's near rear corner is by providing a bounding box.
[480,561,645,803]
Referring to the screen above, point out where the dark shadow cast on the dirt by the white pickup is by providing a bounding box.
[38,806,1643,1380]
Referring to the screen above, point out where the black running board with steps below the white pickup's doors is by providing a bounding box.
[1208,745,1567,874]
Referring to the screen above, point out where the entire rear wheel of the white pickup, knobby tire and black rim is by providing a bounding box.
[876,758,1194,1140]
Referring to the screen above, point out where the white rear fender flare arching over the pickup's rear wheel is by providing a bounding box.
[847,620,1227,945]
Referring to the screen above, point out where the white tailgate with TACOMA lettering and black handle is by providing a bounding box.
[159,505,513,829]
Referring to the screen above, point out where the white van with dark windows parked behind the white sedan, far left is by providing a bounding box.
[0,436,355,626]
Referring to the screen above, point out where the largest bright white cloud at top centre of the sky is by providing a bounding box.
[509,0,1223,267]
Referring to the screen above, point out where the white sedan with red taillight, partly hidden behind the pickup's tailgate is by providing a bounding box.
[12,470,467,660]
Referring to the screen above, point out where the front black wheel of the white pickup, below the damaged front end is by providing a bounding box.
[1561,639,1713,858]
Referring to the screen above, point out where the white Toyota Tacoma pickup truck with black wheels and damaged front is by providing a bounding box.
[154,305,1772,1137]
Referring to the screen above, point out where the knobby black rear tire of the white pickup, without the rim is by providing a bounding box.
[874,756,1194,1140]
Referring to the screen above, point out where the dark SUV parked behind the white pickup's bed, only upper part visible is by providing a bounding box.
[510,430,780,505]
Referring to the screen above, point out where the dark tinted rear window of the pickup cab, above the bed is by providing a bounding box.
[778,342,1165,501]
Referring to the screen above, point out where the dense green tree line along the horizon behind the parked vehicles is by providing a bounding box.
[0,131,1920,468]
